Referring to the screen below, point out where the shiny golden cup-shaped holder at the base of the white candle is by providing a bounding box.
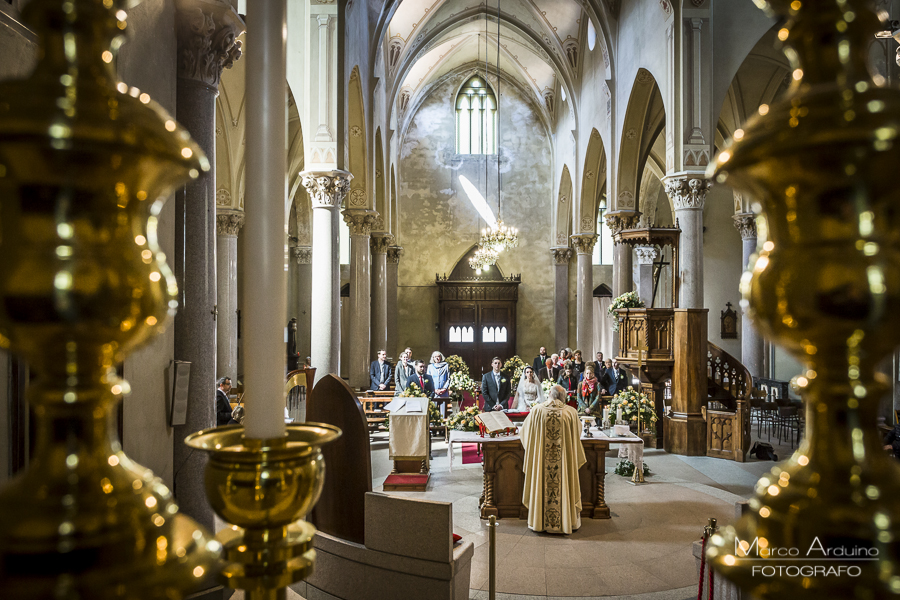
[185,423,341,600]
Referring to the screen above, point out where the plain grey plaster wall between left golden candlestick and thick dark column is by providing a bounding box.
[116,0,178,486]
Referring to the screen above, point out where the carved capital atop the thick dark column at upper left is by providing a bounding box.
[175,0,245,90]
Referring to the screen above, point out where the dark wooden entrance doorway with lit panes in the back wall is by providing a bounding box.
[437,246,522,381]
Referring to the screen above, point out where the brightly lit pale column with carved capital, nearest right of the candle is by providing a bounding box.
[298,171,353,379]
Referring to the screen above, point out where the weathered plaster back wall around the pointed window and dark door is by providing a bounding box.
[398,74,552,366]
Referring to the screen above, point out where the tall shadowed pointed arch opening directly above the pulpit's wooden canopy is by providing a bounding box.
[612,68,673,211]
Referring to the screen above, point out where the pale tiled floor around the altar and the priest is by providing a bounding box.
[372,432,790,600]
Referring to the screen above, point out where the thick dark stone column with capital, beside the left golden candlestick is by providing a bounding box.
[173,0,244,531]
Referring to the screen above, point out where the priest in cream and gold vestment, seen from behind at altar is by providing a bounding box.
[521,385,587,534]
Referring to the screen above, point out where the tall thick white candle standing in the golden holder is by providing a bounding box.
[241,0,287,439]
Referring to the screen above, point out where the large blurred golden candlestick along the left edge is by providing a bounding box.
[0,0,220,599]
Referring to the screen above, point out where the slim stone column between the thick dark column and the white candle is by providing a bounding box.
[216,210,244,381]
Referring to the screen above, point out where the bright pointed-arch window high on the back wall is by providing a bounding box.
[456,75,497,154]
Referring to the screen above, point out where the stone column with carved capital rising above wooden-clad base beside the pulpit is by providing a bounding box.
[665,174,712,308]
